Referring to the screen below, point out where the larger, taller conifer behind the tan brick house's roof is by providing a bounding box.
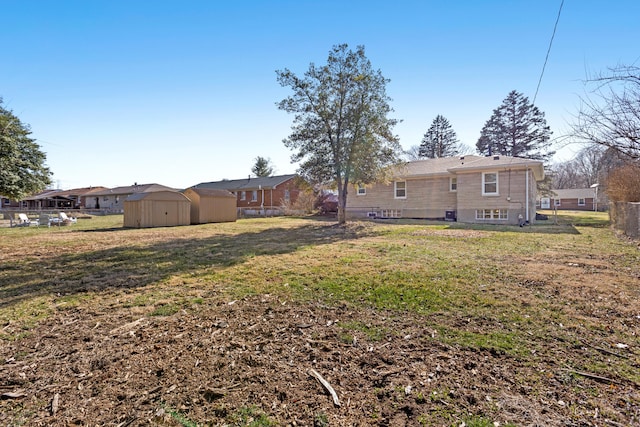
[476,90,554,161]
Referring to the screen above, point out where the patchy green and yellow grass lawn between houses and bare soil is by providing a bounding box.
[0,212,640,426]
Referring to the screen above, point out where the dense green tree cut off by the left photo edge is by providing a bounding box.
[0,98,51,200]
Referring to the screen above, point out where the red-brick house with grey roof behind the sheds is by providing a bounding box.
[191,175,302,215]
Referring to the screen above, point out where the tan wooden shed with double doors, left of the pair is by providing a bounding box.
[124,191,191,228]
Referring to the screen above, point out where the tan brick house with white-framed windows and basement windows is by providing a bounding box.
[347,156,544,224]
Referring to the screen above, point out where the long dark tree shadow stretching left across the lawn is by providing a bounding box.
[0,221,370,309]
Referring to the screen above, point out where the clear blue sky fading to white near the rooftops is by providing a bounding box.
[0,0,640,189]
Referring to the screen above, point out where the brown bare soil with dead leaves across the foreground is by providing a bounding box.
[0,219,640,426]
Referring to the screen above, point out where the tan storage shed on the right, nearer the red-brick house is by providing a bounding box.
[184,188,238,224]
